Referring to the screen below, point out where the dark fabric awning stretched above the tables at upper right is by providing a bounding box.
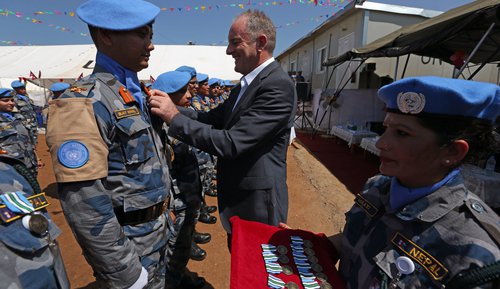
[323,0,500,66]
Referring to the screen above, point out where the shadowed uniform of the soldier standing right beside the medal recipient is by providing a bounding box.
[166,139,202,288]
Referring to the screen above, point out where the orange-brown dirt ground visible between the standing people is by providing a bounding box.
[37,135,354,289]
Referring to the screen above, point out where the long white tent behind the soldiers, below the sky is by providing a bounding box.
[0,44,241,105]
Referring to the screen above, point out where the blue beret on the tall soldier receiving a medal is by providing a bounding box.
[76,0,160,30]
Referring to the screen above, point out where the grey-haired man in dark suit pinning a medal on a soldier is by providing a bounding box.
[150,10,297,243]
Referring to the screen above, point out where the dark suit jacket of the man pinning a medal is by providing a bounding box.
[169,61,297,233]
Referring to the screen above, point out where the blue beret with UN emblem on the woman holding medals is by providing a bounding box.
[378,76,500,122]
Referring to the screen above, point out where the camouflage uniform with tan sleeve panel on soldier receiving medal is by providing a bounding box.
[47,66,171,289]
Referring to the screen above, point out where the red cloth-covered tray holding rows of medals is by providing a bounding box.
[230,217,346,289]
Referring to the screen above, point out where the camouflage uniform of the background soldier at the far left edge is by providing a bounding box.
[0,113,38,176]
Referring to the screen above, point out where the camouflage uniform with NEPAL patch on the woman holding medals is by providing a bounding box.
[339,174,500,289]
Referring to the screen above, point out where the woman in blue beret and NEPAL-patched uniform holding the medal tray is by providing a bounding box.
[334,77,500,289]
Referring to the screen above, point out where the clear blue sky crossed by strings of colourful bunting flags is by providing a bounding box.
[0,0,471,55]
